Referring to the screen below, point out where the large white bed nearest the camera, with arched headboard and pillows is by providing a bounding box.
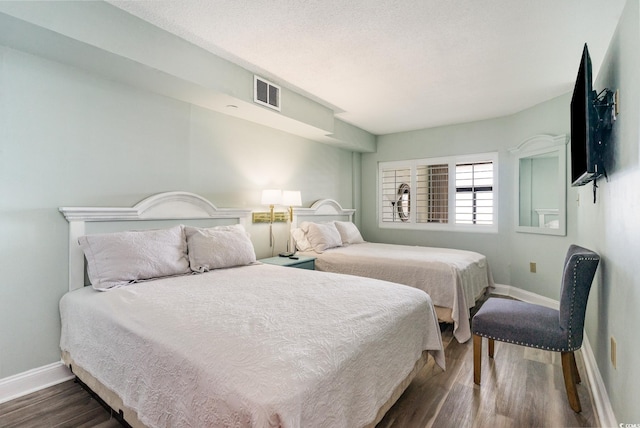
[60,192,444,427]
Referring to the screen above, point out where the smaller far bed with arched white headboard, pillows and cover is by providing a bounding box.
[291,199,493,342]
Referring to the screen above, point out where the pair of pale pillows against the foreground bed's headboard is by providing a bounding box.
[78,224,256,290]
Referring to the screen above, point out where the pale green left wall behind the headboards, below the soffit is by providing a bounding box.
[0,46,359,379]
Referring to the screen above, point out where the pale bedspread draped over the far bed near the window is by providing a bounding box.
[300,242,493,342]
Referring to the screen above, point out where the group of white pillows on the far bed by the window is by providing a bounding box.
[291,221,365,254]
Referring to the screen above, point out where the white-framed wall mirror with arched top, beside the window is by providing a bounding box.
[509,135,568,236]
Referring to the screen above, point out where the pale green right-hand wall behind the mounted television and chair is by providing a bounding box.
[577,0,640,424]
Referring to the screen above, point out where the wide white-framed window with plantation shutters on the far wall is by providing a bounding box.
[378,153,498,232]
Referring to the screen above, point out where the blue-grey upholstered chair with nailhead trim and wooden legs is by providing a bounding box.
[471,245,600,412]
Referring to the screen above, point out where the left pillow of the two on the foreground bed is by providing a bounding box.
[78,226,191,291]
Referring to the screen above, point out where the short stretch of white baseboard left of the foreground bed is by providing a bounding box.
[0,362,74,403]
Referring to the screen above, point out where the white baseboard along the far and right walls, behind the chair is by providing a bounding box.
[493,284,618,427]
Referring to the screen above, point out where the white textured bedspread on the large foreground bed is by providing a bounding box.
[60,265,444,427]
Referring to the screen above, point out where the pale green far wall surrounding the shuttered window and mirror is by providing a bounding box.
[362,95,575,292]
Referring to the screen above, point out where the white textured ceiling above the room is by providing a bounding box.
[109,0,625,135]
